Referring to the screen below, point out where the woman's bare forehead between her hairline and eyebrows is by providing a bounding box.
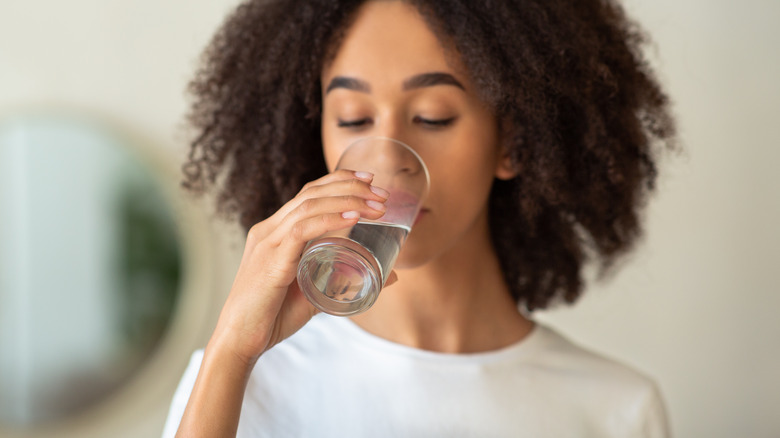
[321,1,462,83]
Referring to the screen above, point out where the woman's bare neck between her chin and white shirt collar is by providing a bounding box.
[352,212,533,353]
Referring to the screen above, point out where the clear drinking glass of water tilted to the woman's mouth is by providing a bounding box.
[298,137,430,316]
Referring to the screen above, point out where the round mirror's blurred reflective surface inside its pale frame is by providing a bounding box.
[0,117,181,427]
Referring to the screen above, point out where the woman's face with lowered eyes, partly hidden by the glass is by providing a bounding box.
[321,1,512,268]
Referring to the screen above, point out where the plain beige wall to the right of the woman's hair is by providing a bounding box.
[550,0,780,438]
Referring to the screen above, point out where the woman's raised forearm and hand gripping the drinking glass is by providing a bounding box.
[176,170,387,438]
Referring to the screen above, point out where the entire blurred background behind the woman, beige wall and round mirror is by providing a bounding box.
[0,0,780,438]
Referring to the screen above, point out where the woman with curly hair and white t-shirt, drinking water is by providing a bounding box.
[165,0,673,437]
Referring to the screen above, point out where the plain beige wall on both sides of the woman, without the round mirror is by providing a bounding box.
[0,0,780,438]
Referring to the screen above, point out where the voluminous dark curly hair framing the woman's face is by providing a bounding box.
[183,0,674,310]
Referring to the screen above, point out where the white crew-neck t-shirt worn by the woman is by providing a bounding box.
[163,314,669,438]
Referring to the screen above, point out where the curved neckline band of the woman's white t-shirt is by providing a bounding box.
[322,315,550,364]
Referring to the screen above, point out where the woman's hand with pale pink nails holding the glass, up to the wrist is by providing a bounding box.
[209,170,395,367]
